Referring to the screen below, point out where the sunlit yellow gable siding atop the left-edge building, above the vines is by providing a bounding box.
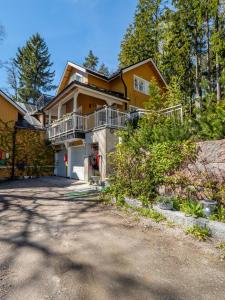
[0,95,19,122]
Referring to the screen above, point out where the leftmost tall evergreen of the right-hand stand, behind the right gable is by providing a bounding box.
[119,0,163,67]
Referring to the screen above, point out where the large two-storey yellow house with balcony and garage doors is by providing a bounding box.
[44,59,166,181]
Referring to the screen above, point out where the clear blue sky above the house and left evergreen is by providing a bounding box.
[0,0,137,94]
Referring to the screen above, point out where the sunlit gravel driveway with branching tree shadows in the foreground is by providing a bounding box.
[0,178,225,300]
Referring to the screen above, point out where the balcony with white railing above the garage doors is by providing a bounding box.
[47,106,129,144]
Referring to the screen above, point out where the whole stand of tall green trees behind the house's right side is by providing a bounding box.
[119,0,225,102]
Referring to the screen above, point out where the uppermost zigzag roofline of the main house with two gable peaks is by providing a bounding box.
[56,58,167,94]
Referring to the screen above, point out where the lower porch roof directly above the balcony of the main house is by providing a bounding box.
[44,80,129,109]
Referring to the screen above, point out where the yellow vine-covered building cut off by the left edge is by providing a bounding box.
[0,90,53,180]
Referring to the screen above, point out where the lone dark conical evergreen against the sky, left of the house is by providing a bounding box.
[14,33,55,103]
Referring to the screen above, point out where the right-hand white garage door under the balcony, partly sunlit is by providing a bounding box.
[70,146,85,180]
